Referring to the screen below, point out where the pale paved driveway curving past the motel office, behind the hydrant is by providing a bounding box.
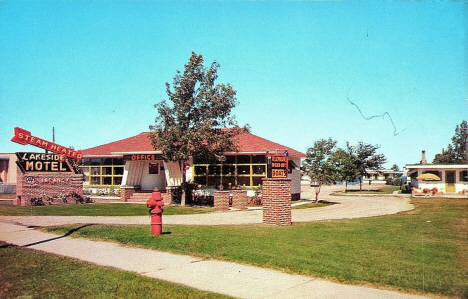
[0,186,414,226]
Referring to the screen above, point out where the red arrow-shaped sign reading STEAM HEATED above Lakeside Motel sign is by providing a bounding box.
[11,127,83,161]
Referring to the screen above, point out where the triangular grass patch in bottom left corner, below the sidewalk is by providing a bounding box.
[0,242,230,299]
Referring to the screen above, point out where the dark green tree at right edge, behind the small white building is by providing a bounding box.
[432,120,468,164]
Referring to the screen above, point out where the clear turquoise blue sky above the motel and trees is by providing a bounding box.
[0,1,468,168]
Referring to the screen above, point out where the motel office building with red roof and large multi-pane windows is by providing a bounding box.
[80,132,305,201]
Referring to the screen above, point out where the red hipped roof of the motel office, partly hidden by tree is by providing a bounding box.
[82,132,305,157]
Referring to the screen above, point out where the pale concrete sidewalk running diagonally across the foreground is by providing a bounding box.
[0,222,432,299]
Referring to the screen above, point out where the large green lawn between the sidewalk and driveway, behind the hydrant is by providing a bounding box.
[44,198,468,298]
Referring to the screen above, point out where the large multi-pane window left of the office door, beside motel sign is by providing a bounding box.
[80,158,125,187]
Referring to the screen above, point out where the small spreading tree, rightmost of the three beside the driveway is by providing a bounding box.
[346,141,387,191]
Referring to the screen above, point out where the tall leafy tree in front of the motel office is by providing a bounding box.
[150,52,248,205]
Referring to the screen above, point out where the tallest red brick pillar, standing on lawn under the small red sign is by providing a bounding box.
[262,178,292,225]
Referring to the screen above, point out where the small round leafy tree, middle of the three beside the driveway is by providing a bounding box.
[332,148,359,192]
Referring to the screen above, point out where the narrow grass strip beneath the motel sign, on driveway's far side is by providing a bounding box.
[0,201,213,216]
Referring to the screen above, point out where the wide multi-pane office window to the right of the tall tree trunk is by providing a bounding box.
[193,155,267,188]
